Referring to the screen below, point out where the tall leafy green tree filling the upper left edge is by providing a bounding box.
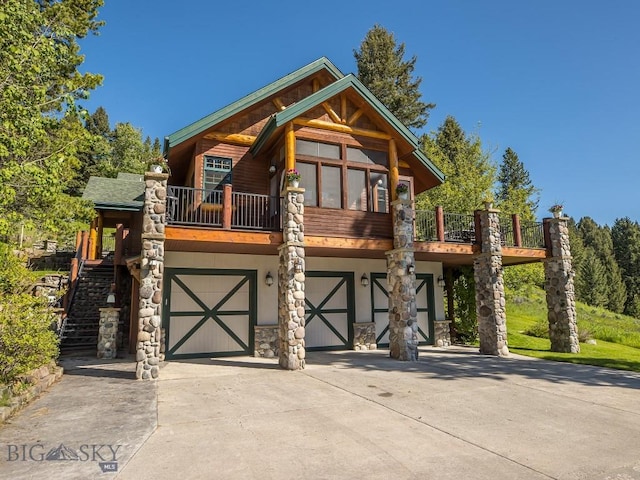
[0,0,102,239]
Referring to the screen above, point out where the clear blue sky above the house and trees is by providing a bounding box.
[81,0,640,225]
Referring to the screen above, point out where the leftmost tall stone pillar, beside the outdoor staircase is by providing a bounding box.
[136,172,169,380]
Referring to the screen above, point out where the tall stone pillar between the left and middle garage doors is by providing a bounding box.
[278,186,306,370]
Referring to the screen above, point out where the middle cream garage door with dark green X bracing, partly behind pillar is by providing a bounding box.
[304,272,355,350]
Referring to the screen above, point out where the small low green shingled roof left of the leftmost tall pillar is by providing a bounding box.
[82,174,145,211]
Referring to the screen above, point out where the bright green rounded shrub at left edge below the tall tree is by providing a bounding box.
[0,294,58,384]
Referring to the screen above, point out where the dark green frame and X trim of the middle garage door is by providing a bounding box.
[305,271,355,351]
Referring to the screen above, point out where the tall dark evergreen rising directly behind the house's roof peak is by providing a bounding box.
[353,25,435,128]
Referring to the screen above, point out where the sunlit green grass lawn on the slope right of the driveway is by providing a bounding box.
[507,288,640,372]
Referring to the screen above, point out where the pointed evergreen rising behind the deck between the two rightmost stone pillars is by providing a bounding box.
[496,147,538,221]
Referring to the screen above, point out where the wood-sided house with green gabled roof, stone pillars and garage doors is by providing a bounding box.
[77,58,577,378]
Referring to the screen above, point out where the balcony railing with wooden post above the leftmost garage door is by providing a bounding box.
[167,185,280,230]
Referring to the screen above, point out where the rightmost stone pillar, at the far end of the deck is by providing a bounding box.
[544,218,580,353]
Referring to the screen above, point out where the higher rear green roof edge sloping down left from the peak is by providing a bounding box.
[165,57,343,150]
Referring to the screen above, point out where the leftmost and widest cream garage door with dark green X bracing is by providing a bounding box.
[163,268,257,359]
